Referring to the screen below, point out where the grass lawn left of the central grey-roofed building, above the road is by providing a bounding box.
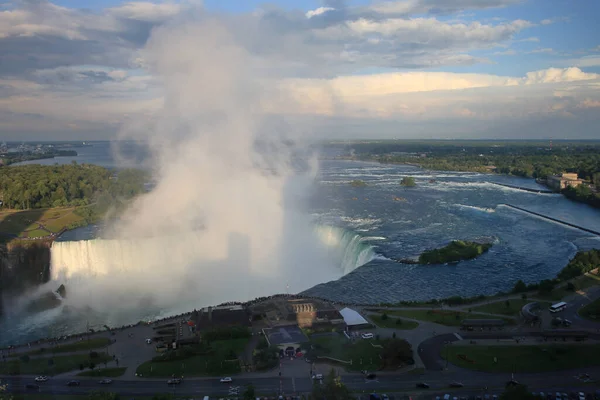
[136,338,249,378]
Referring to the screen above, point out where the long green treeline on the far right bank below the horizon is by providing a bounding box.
[347,140,600,208]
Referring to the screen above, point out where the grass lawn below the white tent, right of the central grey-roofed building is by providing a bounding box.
[308,335,381,371]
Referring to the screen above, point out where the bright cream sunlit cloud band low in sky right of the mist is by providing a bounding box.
[268,68,600,119]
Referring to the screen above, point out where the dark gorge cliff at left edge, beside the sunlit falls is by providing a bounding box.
[0,240,52,314]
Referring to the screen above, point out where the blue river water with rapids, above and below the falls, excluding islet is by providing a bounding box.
[0,143,600,344]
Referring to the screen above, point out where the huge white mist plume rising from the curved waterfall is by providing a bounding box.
[52,10,360,318]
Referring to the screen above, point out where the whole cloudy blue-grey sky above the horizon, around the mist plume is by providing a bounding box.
[0,0,600,140]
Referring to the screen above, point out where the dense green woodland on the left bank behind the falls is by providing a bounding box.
[0,163,148,212]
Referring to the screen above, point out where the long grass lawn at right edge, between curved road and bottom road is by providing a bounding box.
[441,344,600,372]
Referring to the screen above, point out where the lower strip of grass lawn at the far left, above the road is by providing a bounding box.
[0,353,112,375]
